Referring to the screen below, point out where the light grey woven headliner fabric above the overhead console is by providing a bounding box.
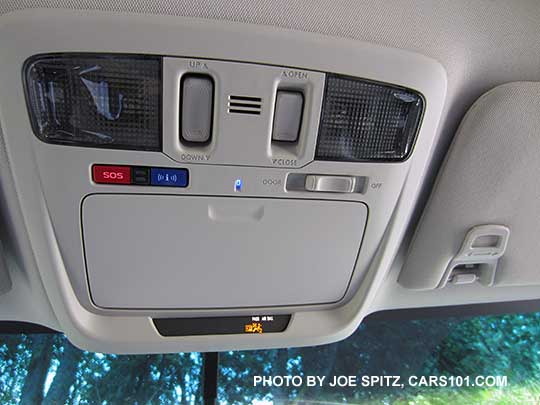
[0,0,540,161]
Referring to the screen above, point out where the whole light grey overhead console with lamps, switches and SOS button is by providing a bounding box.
[0,8,446,352]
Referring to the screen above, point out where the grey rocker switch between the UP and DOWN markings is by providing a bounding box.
[180,75,214,144]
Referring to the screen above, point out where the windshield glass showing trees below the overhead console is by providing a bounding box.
[0,313,540,404]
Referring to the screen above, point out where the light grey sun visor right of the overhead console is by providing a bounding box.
[399,82,540,289]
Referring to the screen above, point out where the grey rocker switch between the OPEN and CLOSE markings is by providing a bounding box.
[272,90,304,142]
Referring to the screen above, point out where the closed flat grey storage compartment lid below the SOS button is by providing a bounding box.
[82,194,367,309]
